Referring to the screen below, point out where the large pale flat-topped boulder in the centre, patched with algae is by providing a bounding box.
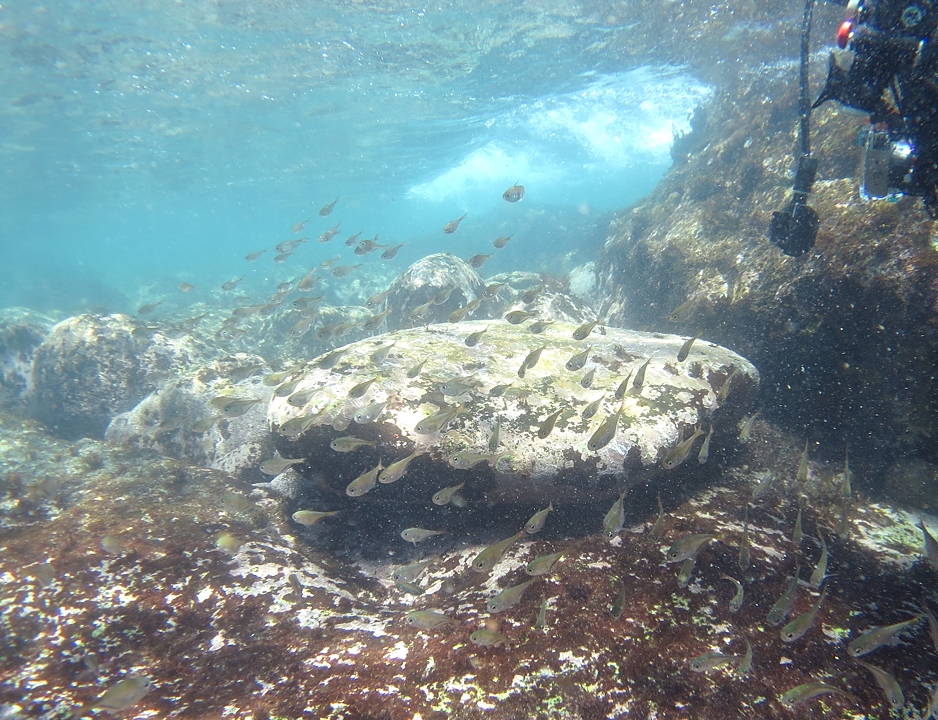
[269,321,759,501]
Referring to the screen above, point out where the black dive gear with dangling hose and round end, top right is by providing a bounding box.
[769,0,938,256]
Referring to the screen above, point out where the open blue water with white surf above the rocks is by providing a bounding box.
[0,2,711,313]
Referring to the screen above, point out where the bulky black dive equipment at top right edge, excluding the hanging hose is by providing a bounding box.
[812,0,938,208]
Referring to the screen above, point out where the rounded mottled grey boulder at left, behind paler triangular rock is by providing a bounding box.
[29,315,211,438]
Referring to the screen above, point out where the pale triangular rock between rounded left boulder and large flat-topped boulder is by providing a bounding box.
[104,353,273,482]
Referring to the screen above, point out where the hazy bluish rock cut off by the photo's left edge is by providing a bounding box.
[0,308,55,407]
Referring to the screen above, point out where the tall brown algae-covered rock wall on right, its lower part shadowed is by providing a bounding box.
[596,64,938,478]
